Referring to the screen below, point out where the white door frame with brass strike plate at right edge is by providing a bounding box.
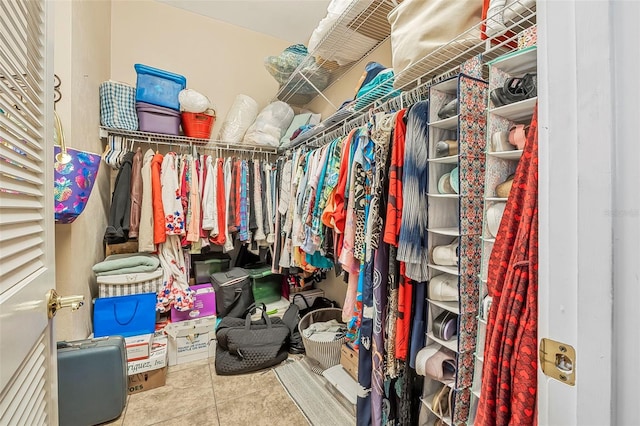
[537,0,640,425]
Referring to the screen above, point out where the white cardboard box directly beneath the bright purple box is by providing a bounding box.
[164,316,216,366]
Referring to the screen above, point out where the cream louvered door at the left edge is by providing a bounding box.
[0,0,58,425]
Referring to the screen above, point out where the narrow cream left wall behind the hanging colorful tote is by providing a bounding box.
[54,0,111,340]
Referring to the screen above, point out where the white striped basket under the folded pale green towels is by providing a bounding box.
[97,268,162,297]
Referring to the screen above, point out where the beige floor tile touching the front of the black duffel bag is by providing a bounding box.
[211,365,282,406]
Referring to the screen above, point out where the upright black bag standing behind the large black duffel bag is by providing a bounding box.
[211,268,255,318]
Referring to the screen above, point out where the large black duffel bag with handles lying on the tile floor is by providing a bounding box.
[215,307,290,376]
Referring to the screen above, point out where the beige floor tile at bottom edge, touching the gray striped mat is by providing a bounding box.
[217,380,308,426]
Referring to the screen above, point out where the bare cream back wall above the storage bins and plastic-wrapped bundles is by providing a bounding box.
[111,0,290,136]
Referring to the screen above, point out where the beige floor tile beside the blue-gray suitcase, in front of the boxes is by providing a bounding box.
[123,362,215,426]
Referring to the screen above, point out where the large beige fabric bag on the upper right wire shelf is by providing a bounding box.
[387,0,482,88]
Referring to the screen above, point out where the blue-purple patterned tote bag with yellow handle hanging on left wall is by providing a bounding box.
[53,111,100,223]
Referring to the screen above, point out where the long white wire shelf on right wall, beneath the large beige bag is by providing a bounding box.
[279,0,536,150]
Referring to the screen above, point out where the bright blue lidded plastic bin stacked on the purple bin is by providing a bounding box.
[133,64,187,111]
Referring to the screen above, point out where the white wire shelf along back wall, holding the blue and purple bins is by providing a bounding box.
[100,127,278,154]
